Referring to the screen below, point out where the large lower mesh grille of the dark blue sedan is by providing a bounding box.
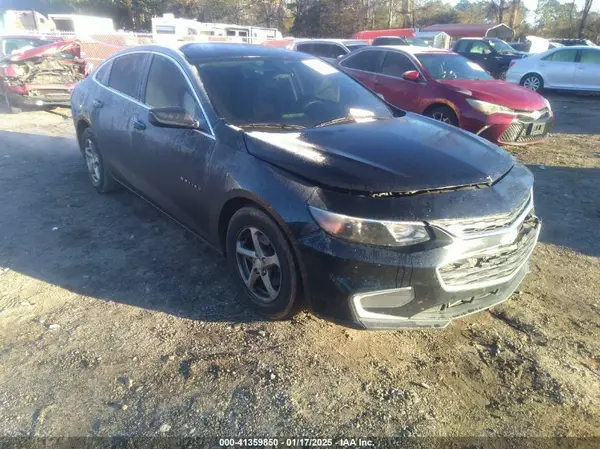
[438,214,539,290]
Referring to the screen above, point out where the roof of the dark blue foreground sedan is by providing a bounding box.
[178,43,310,61]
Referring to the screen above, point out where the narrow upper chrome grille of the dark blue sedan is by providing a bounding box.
[431,193,533,236]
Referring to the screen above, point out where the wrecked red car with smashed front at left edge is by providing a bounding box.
[0,36,91,113]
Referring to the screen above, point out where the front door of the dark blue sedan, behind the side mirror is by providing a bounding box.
[137,54,216,234]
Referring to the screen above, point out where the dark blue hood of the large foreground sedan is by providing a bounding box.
[245,113,514,193]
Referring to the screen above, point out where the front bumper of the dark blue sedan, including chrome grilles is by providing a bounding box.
[300,191,541,329]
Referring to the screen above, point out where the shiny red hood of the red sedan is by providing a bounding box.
[440,80,547,111]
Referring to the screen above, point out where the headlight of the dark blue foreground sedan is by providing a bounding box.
[309,206,430,246]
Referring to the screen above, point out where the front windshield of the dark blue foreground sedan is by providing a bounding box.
[195,57,393,129]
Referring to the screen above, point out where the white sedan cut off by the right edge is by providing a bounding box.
[506,45,600,92]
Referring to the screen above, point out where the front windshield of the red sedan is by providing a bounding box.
[415,53,493,80]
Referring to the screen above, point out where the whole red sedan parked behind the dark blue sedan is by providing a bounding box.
[339,46,554,145]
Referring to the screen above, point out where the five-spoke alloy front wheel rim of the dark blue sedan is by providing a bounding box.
[236,227,282,303]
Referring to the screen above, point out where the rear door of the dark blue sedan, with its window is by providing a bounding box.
[91,52,148,189]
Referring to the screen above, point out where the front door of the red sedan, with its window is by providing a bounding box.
[374,50,423,111]
